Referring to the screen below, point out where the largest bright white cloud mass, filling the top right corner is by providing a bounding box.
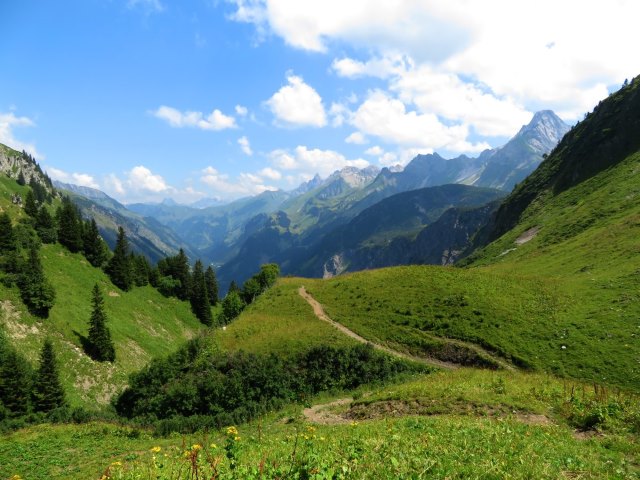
[231,0,640,122]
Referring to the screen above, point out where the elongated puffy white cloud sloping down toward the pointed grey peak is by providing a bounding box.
[353,90,489,152]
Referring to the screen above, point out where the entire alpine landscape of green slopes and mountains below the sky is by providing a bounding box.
[0,77,640,480]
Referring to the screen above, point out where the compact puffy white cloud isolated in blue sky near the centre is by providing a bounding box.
[266,75,327,127]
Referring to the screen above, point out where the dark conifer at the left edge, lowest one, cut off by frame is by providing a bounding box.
[0,332,33,419]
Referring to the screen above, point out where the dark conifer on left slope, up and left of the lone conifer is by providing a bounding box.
[18,246,56,318]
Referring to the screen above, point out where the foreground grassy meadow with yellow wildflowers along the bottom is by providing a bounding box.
[0,369,640,479]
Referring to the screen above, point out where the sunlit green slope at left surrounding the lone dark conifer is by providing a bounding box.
[0,245,201,408]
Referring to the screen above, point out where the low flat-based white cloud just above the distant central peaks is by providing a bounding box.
[270,145,369,178]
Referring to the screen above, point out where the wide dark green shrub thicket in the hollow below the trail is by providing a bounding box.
[115,340,414,425]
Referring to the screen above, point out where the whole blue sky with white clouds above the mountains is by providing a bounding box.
[0,0,640,203]
